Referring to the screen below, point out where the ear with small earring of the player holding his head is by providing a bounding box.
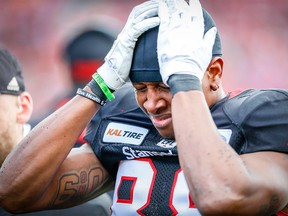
[207,57,224,91]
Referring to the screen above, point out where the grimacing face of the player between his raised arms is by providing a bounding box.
[133,82,174,138]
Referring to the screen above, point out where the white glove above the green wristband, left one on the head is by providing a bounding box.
[97,0,160,90]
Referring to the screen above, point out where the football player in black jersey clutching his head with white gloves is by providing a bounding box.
[0,0,288,215]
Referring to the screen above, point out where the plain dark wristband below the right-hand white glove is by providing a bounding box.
[167,74,202,97]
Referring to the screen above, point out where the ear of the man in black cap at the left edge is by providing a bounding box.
[17,91,33,124]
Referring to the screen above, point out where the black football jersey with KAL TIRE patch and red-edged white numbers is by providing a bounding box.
[85,84,288,216]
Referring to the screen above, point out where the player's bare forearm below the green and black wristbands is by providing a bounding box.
[0,88,99,209]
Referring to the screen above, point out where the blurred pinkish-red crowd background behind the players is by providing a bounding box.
[0,0,288,122]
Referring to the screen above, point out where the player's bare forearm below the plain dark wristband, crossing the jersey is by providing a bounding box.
[172,91,253,213]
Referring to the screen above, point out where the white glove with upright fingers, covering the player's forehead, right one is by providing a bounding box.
[157,0,217,86]
